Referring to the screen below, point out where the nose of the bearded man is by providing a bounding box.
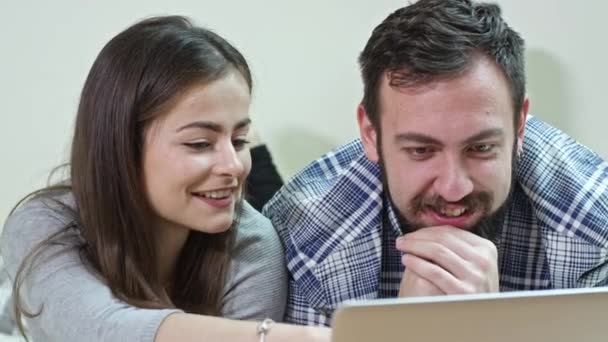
[433,157,473,202]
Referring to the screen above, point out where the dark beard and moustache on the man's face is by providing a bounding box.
[377,139,519,243]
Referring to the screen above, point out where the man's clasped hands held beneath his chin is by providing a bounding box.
[396,226,498,297]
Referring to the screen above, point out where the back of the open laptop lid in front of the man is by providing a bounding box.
[332,288,608,342]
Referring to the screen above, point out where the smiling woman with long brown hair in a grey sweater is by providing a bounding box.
[0,17,329,342]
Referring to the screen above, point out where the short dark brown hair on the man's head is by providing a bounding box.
[359,0,526,129]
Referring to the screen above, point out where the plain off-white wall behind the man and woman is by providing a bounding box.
[0,0,608,224]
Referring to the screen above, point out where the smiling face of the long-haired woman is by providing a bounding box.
[143,72,251,238]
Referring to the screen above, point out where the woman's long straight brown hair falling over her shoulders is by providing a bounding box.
[13,16,252,336]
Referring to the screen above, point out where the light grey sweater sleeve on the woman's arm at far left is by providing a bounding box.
[0,201,179,342]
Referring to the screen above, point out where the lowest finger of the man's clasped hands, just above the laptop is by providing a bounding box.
[402,254,474,294]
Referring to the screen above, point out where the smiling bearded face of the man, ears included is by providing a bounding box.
[359,58,528,231]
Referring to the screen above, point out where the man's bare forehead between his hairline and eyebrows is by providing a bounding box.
[379,58,514,140]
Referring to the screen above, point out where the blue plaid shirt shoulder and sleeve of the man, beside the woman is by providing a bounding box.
[263,140,382,310]
